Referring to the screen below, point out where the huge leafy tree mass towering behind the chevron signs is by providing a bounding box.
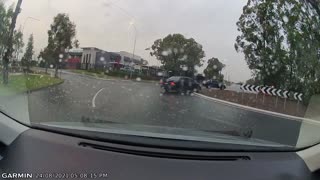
[235,0,320,102]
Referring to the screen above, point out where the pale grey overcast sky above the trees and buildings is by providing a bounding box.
[6,0,250,82]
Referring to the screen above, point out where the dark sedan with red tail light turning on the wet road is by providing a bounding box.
[160,76,201,93]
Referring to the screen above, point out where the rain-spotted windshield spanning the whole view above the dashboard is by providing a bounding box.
[0,0,320,150]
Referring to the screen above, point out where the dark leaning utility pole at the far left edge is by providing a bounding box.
[2,0,22,84]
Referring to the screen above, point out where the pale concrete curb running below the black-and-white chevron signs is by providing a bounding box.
[194,93,319,124]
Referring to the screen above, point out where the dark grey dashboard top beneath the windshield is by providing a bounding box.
[0,129,320,180]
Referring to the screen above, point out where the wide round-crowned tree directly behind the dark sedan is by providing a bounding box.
[150,34,205,76]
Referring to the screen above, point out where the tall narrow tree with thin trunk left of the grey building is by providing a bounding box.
[41,14,79,77]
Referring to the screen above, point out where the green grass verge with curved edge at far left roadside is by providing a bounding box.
[0,74,63,95]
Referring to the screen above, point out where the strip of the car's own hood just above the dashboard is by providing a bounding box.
[39,122,293,148]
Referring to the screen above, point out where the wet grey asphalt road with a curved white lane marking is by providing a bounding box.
[22,73,301,145]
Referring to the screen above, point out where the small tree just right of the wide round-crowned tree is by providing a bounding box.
[203,57,225,81]
